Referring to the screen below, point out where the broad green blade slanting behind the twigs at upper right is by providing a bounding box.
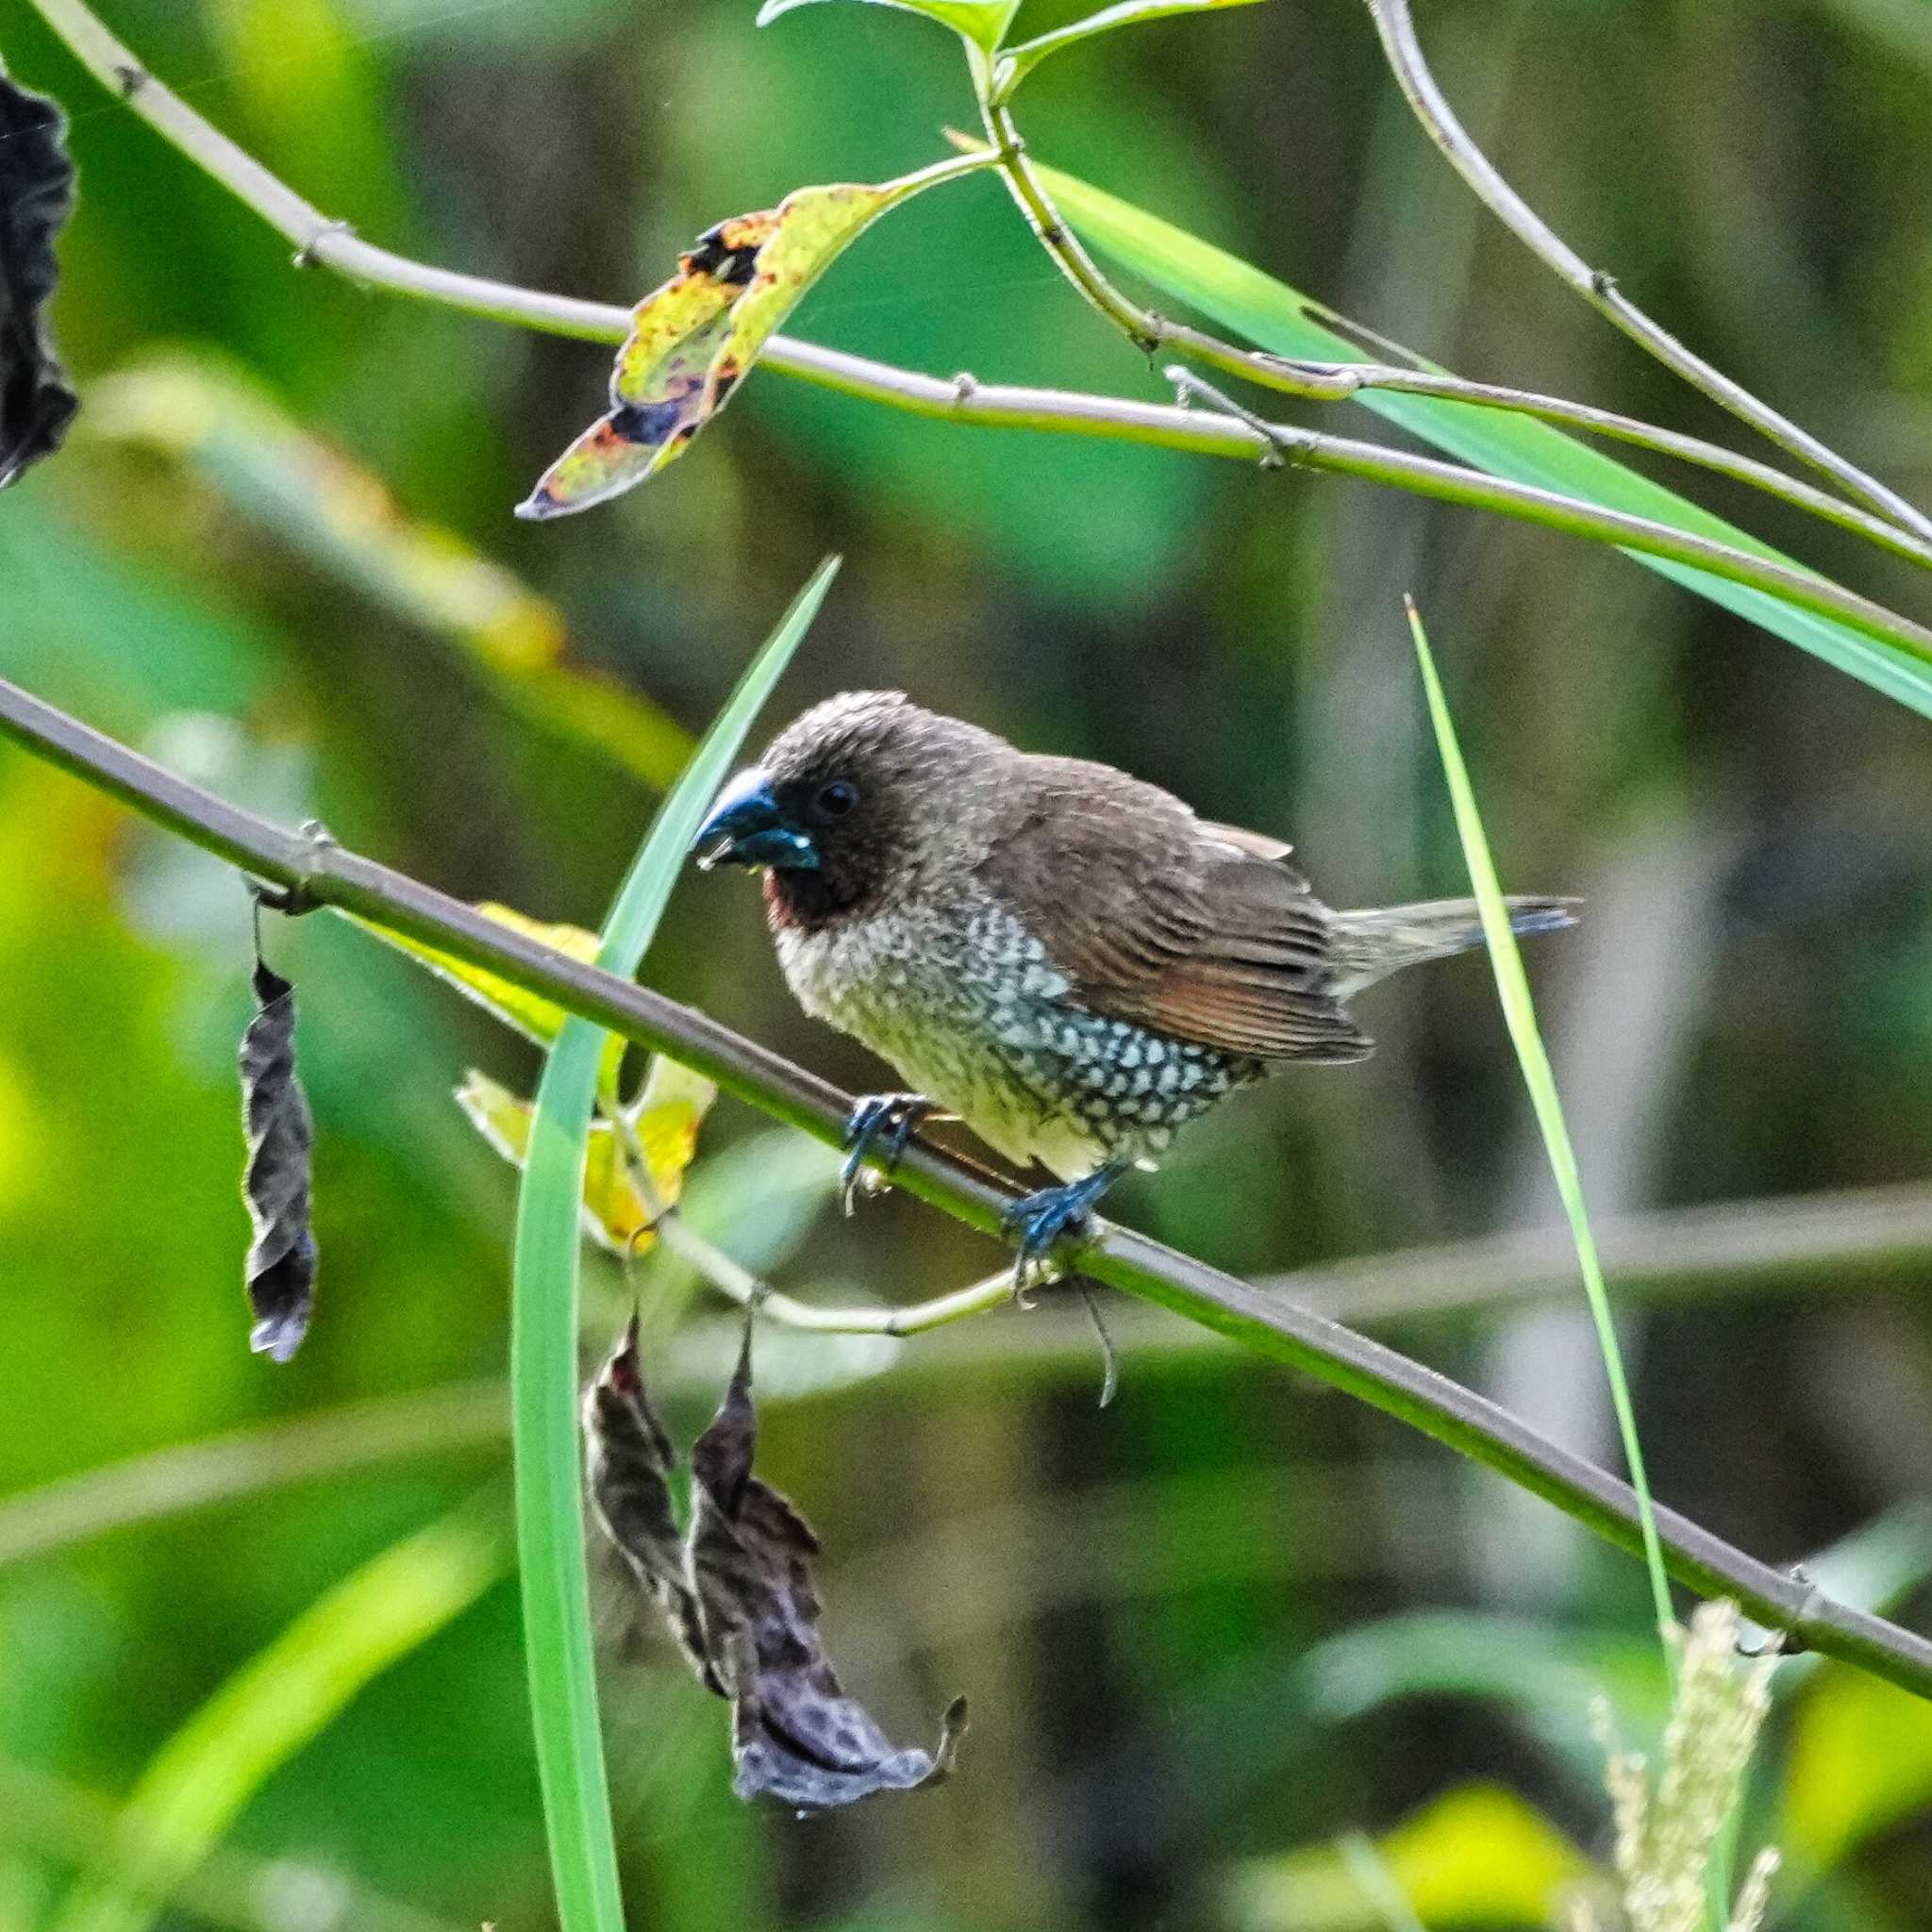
[1036,164,1932,717]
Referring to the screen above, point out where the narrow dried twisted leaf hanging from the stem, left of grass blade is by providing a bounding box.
[242,958,317,1362]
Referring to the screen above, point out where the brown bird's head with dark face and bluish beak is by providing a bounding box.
[691,691,1010,925]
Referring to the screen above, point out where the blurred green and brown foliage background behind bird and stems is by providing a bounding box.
[0,0,1932,1932]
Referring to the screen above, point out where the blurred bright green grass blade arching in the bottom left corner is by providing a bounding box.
[59,1511,505,1932]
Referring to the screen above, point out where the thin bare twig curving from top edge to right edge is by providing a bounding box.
[1366,0,1932,539]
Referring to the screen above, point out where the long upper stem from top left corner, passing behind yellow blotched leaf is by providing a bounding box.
[33,0,1932,622]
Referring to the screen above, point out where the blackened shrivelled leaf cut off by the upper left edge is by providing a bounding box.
[0,72,79,489]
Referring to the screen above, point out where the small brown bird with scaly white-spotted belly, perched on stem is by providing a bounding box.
[693,691,1571,1283]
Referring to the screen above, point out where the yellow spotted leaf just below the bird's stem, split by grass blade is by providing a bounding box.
[456,1058,717,1254]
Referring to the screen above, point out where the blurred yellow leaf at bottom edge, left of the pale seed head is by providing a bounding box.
[1231,1783,1596,1932]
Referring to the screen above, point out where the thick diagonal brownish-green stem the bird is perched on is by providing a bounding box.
[0,680,1932,1698]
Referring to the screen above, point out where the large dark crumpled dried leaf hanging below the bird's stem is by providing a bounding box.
[583,1322,966,1810]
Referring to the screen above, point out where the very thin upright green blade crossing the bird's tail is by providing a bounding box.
[1408,605,1674,1657]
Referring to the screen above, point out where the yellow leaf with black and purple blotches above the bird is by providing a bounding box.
[516,168,944,520]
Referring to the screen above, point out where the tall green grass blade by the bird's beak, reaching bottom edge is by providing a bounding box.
[510,558,839,1932]
